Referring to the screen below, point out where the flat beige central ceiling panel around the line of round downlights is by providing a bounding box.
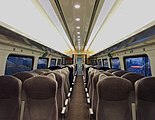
[52,0,95,49]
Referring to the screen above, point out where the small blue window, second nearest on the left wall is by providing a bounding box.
[37,58,48,69]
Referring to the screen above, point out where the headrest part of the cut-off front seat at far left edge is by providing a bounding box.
[0,75,22,99]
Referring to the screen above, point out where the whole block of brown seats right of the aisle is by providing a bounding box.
[83,65,155,120]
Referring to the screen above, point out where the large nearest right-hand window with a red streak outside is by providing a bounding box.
[124,55,151,76]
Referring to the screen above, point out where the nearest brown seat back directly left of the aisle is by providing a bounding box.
[23,76,58,120]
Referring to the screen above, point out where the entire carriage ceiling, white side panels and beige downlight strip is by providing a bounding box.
[0,0,155,55]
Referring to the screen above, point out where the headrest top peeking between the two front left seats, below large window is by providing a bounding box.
[13,72,36,82]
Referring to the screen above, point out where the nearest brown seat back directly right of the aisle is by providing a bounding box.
[96,76,132,120]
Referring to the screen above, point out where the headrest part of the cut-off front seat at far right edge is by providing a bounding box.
[135,77,155,102]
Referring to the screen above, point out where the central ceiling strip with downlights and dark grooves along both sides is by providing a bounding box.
[40,0,104,51]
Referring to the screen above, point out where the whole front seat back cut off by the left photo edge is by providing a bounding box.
[0,76,22,120]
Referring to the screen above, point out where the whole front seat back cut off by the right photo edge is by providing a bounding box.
[135,77,155,120]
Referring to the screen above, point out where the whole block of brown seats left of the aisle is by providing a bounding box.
[0,65,76,120]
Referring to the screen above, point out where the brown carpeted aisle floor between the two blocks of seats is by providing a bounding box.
[67,75,89,120]
